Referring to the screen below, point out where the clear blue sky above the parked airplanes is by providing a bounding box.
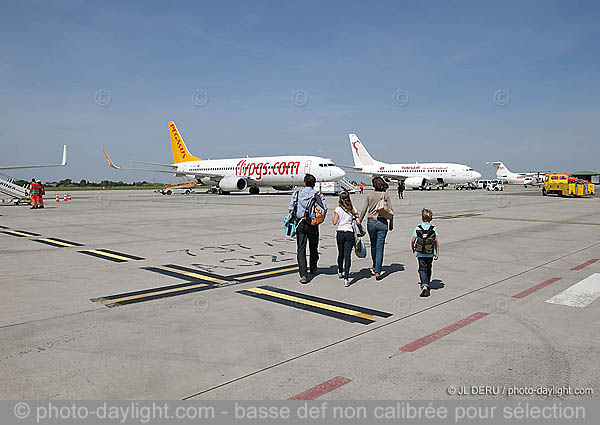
[0,0,600,181]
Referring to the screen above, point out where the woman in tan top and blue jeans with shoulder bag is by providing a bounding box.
[360,177,394,280]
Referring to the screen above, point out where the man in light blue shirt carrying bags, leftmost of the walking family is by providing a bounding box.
[288,174,327,285]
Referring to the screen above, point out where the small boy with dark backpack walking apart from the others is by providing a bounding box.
[410,208,440,297]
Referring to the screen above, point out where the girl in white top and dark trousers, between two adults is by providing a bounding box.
[332,191,360,288]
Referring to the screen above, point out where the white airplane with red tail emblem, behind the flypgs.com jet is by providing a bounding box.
[348,134,481,189]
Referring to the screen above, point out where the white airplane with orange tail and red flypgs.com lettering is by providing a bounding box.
[102,121,346,194]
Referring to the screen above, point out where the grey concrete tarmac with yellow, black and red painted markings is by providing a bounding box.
[0,187,600,400]
